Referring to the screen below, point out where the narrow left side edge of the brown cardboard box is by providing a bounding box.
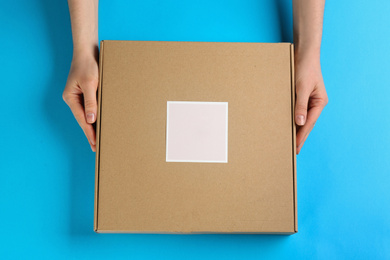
[93,41,104,233]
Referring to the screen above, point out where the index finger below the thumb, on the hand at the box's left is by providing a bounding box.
[68,96,96,147]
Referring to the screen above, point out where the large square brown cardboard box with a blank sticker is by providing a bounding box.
[94,41,297,234]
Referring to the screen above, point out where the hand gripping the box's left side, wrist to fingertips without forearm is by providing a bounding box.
[62,51,99,152]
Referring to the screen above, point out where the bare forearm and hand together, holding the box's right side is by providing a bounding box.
[293,0,328,154]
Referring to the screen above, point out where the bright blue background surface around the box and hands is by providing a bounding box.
[0,0,390,259]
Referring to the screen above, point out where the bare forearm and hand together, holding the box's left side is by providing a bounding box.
[62,0,99,152]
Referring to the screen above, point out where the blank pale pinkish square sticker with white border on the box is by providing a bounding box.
[166,101,228,163]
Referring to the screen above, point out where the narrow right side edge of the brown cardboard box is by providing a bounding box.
[290,44,298,233]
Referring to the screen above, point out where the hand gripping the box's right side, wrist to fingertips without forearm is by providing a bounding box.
[295,51,328,154]
